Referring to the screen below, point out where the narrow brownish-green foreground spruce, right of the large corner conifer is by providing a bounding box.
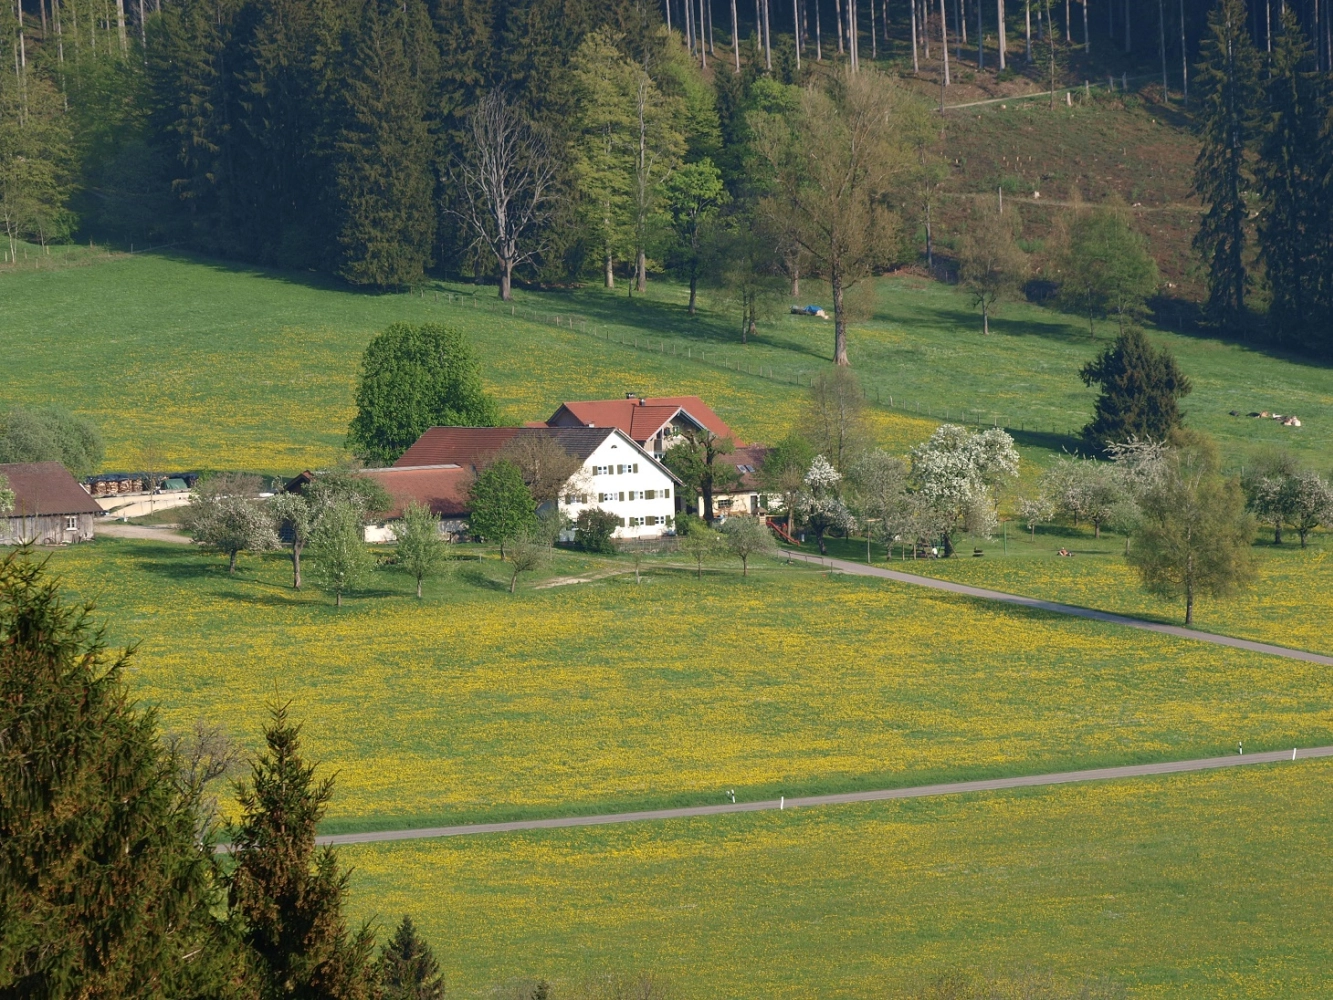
[229,707,373,1000]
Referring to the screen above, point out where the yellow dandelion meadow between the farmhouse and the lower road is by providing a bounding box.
[52,539,1333,829]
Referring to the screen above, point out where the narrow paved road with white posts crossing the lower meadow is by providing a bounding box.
[317,747,1333,845]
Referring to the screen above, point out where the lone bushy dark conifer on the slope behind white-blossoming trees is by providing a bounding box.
[1078,327,1193,453]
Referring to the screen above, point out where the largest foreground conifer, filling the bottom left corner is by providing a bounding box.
[0,549,253,1000]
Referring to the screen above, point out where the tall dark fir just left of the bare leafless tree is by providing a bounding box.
[335,0,436,288]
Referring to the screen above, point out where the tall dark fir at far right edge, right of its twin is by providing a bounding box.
[1254,8,1330,344]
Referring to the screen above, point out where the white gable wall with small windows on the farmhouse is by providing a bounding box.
[560,432,676,539]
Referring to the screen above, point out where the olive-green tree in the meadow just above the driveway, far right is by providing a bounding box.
[1129,435,1254,625]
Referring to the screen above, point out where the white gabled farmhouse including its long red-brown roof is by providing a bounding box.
[393,427,680,539]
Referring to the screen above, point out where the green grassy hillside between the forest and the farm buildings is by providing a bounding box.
[0,255,1333,473]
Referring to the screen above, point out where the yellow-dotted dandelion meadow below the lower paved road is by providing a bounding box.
[340,760,1333,1000]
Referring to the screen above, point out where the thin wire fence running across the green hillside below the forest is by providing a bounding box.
[421,291,1078,439]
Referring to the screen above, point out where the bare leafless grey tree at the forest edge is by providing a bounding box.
[451,91,556,301]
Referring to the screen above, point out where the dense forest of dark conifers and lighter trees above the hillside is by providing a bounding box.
[0,0,1333,352]
